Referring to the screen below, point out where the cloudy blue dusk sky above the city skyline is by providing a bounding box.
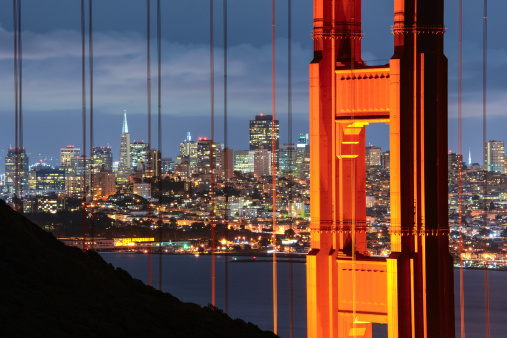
[0,0,507,167]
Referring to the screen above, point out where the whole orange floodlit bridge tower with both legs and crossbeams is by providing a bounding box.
[307,0,455,338]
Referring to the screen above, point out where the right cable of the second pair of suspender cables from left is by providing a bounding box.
[88,0,95,250]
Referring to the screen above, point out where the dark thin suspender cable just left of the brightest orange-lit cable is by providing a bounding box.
[223,0,229,314]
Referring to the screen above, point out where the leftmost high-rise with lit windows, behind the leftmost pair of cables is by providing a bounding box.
[5,148,28,192]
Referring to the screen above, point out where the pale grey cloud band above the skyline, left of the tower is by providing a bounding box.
[0,28,312,116]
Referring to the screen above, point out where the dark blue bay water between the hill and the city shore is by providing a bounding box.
[101,252,507,338]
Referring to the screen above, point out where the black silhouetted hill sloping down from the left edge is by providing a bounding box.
[0,200,276,337]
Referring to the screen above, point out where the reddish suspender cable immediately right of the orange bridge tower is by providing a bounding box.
[458,0,465,338]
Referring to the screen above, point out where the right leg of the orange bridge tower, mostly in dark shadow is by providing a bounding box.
[388,0,454,337]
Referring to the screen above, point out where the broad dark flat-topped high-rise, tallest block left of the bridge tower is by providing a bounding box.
[250,114,280,152]
